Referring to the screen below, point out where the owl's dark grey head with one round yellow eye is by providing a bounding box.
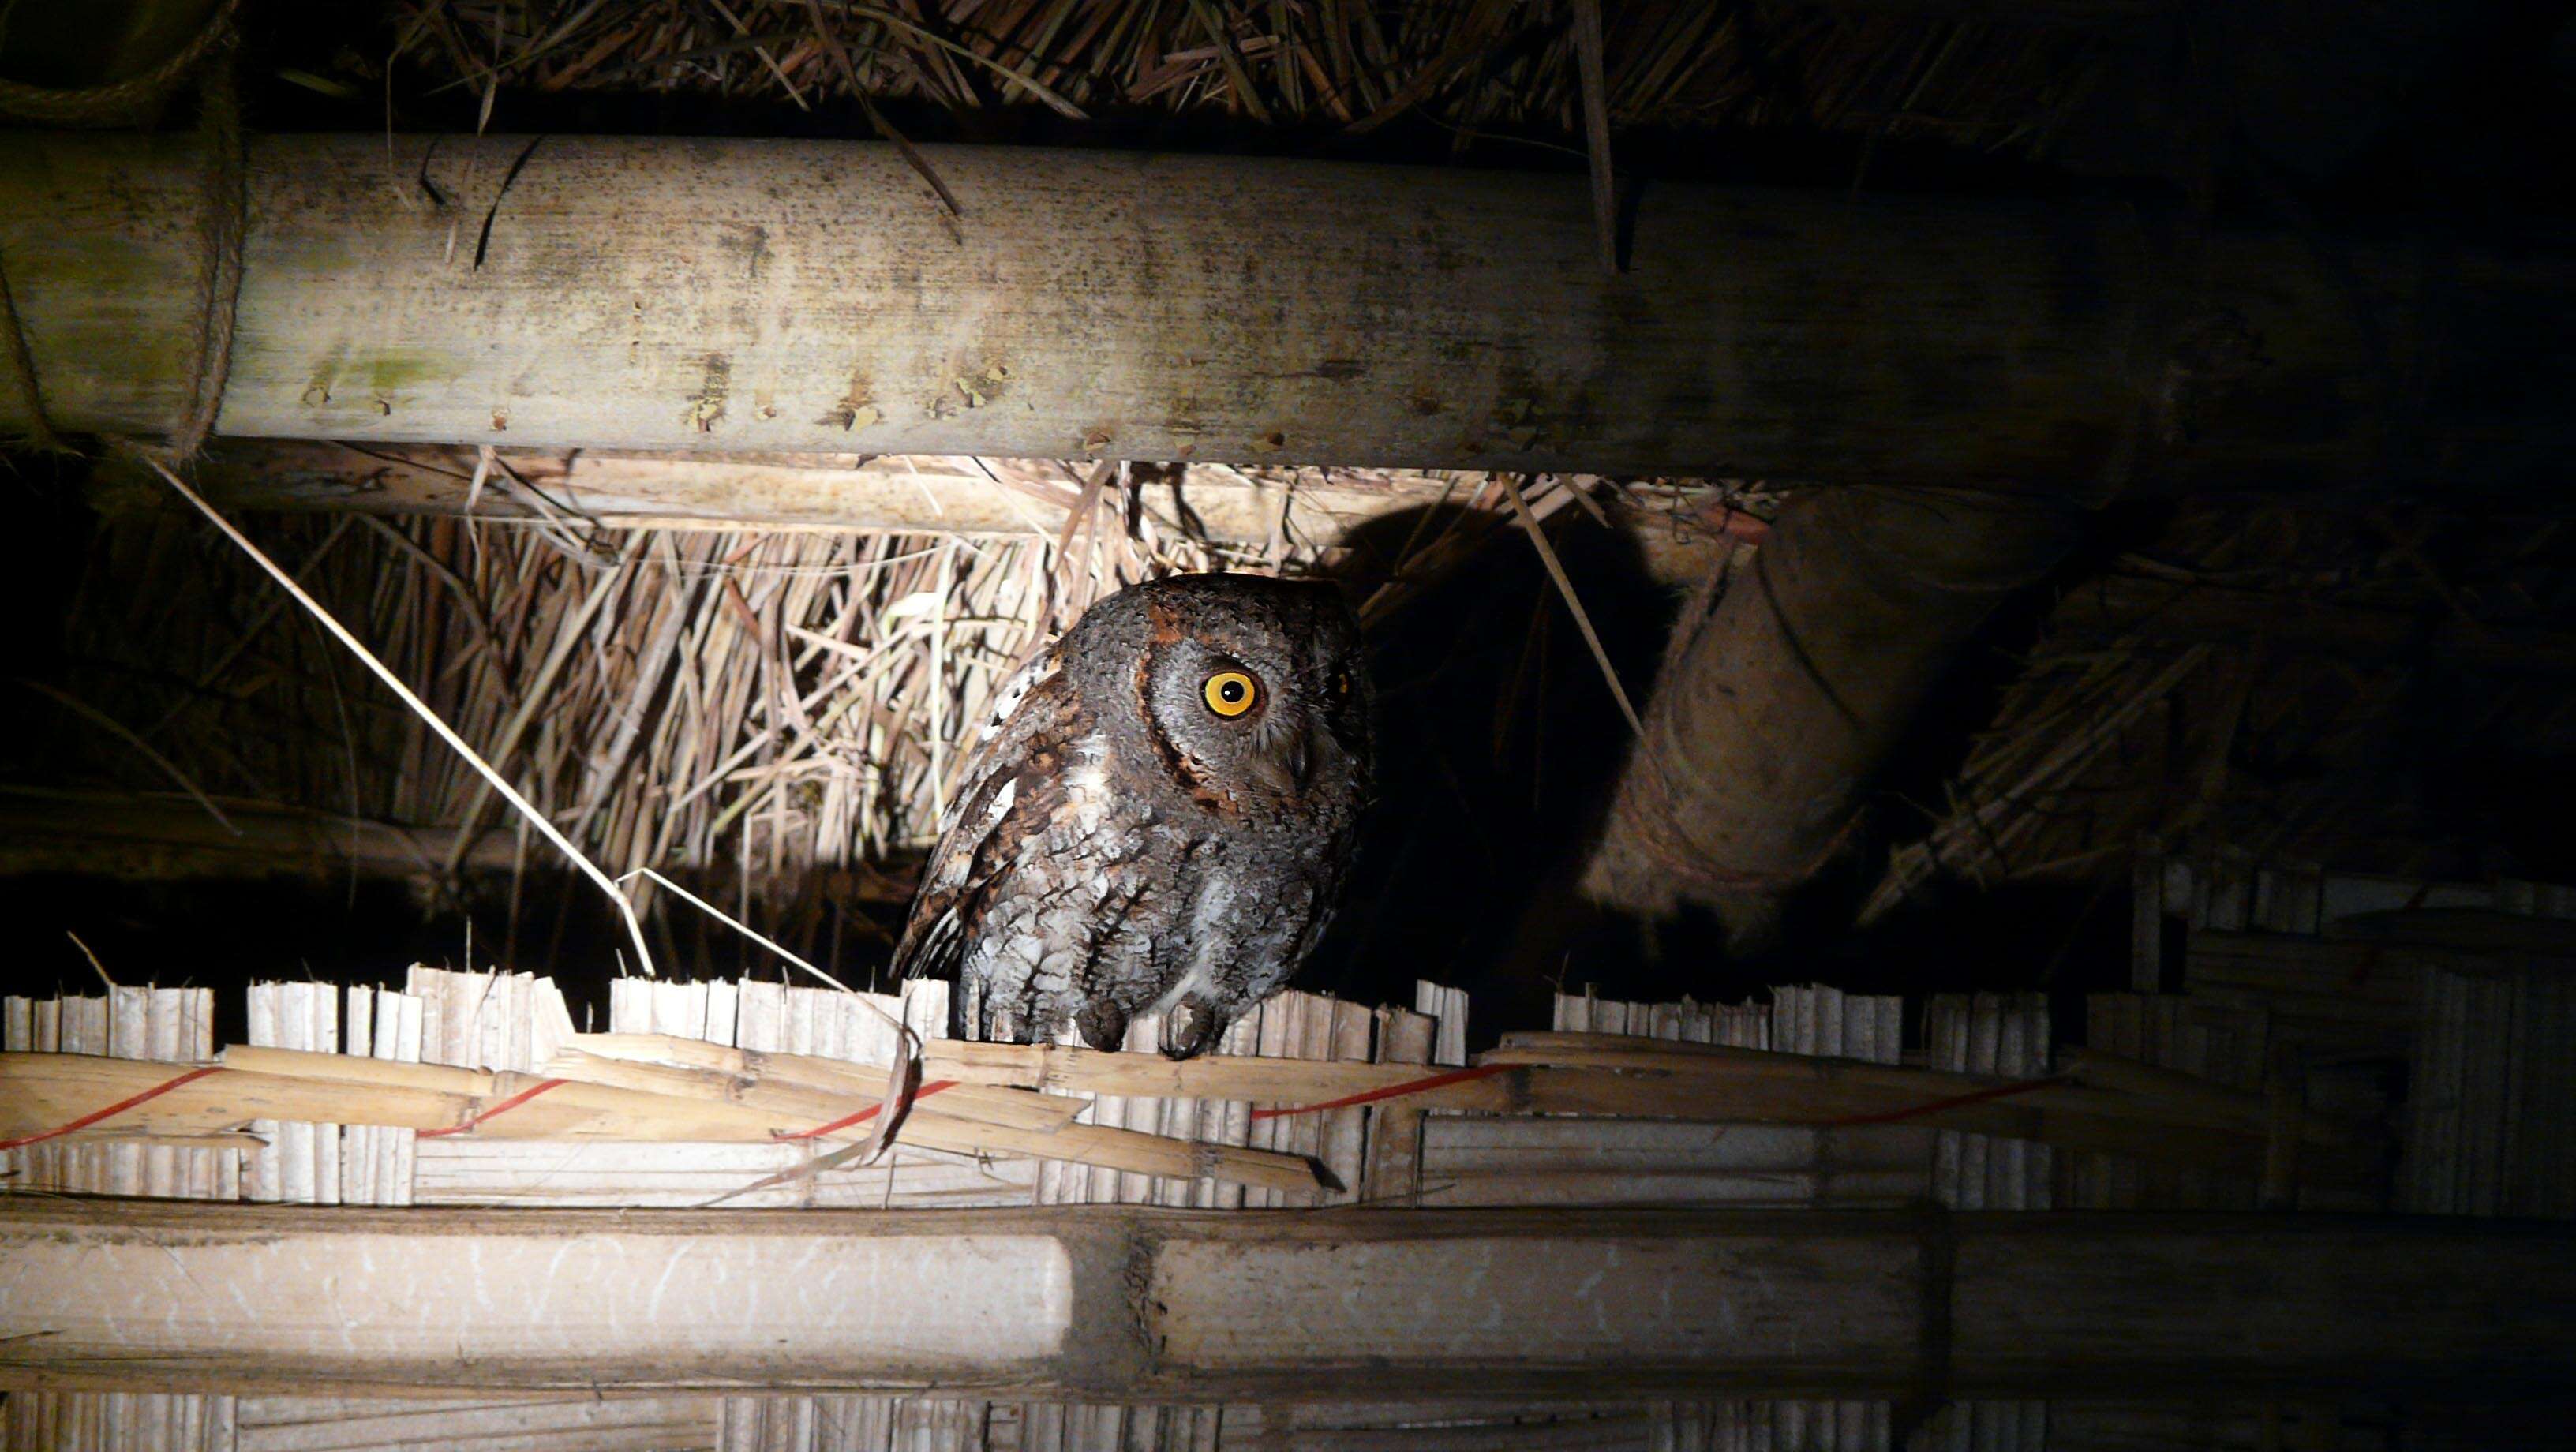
[1064,574,1370,811]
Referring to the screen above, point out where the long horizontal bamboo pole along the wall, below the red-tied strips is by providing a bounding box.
[0,1203,2576,1403]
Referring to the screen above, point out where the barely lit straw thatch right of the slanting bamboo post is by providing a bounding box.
[1863,497,2576,919]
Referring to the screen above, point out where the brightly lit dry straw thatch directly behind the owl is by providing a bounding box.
[35,450,1698,958]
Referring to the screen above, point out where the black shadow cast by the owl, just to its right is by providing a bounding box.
[1298,507,1677,1027]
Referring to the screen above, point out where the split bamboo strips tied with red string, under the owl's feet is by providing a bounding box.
[0,1014,2380,1192]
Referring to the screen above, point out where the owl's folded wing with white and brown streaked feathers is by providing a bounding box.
[894,649,1074,979]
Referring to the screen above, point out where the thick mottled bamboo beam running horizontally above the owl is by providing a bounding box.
[0,134,2576,487]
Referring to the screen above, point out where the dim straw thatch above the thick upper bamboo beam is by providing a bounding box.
[373,0,2099,159]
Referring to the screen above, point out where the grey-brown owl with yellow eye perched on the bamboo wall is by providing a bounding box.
[894,574,1370,1058]
